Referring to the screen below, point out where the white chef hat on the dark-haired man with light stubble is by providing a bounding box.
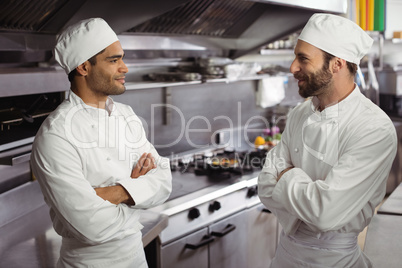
[54,18,119,74]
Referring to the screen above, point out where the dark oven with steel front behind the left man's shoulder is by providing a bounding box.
[0,92,64,194]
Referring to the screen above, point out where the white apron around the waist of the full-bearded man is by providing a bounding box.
[271,225,372,268]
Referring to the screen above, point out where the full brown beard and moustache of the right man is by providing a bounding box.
[294,64,332,98]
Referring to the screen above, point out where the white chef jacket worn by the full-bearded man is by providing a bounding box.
[258,85,397,267]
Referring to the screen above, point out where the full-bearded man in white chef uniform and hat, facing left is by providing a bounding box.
[258,14,397,268]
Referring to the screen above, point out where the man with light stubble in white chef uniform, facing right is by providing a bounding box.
[31,18,172,268]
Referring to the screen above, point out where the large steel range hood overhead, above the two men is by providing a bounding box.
[0,0,347,64]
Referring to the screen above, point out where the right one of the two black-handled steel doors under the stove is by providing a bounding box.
[209,210,247,268]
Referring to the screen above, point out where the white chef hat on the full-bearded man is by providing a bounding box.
[299,13,373,65]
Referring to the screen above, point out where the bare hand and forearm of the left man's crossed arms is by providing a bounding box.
[95,153,156,206]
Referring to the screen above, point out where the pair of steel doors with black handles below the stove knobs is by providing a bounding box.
[161,211,248,268]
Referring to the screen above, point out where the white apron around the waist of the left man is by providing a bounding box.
[57,232,148,268]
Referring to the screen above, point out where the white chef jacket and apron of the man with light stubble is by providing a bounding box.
[31,91,172,267]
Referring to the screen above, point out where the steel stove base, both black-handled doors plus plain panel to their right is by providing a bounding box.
[160,204,277,268]
